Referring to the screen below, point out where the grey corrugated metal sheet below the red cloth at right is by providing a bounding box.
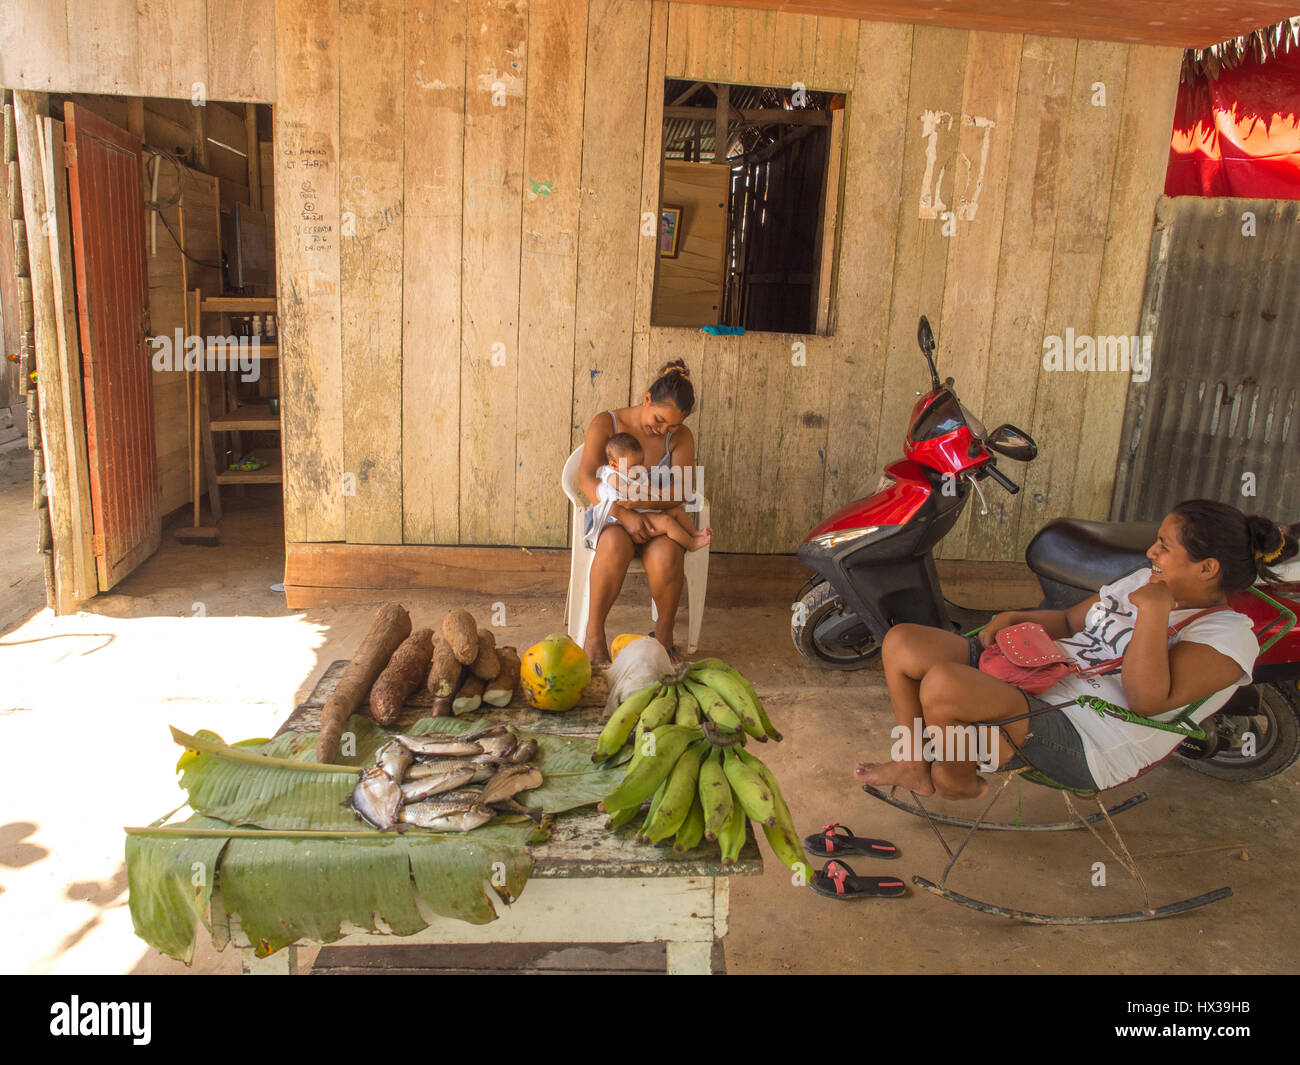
[1112,196,1300,520]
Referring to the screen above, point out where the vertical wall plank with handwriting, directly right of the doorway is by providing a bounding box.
[274,0,345,542]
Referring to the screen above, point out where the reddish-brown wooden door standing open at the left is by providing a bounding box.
[64,103,161,592]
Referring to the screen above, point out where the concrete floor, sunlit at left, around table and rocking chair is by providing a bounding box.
[0,457,1300,974]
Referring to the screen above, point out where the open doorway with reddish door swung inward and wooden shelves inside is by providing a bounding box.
[5,92,282,606]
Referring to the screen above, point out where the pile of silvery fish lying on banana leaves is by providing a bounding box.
[351,724,542,832]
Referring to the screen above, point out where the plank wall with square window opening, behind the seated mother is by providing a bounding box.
[274,0,1180,559]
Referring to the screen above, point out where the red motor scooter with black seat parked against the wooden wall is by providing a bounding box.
[790,317,1300,780]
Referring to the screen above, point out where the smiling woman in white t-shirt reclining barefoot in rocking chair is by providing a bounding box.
[854,499,1297,798]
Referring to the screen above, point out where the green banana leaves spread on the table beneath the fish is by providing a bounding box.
[126,717,624,964]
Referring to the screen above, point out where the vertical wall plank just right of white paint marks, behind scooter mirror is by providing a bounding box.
[966,36,1076,562]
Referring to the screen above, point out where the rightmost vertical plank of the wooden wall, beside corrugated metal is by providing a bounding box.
[1070,44,1182,520]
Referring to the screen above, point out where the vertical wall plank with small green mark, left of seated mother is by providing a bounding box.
[510,0,587,547]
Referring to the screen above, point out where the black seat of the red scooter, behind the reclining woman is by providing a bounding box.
[1024,518,1160,592]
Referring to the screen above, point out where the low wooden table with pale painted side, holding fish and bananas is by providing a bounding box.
[223,662,763,974]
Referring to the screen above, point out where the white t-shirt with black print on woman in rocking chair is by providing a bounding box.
[1039,570,1260,788]
